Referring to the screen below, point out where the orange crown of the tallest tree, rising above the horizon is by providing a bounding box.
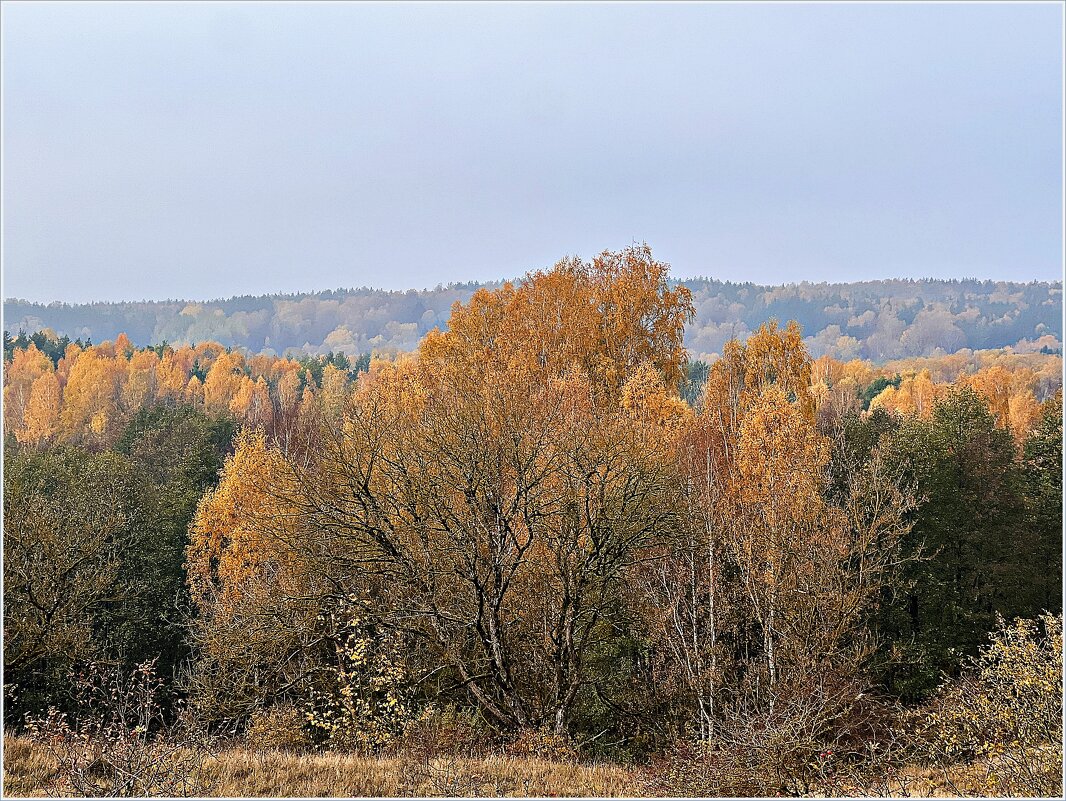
[419,245,693,402]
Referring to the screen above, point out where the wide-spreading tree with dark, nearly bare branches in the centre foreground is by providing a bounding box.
[277,367,672,732]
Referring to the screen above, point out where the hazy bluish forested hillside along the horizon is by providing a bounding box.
[3,278,1063,361]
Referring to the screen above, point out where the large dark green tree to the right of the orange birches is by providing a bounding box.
[881,387,1035,699]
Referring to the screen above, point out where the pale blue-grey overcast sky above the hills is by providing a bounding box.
[0,2,1063,302]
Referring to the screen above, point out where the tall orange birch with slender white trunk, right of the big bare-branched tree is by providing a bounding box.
[679,323,874,708]
